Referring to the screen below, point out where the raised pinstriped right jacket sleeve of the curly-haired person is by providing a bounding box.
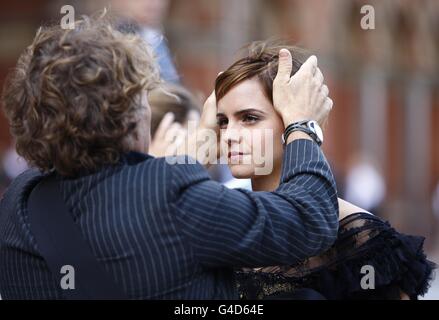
[171,139,338,267]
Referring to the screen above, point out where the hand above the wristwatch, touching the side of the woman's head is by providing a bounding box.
[273,49,333,127]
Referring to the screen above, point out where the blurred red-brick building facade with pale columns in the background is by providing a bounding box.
[0,0,439,246]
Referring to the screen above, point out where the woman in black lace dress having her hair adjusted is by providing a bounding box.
[215,42,435,300]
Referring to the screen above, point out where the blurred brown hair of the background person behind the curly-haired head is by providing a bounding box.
[148,84,201,136]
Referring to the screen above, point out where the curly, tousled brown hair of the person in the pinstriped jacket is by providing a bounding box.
[2,12,160,176]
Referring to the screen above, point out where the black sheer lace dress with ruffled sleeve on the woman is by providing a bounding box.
[235,213,435,300]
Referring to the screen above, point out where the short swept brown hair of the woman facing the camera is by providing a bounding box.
[215,41,310,103]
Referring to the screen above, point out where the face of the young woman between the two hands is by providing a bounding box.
[217,78,284,178]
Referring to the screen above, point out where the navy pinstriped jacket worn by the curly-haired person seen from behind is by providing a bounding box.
[0,140,338,299]
